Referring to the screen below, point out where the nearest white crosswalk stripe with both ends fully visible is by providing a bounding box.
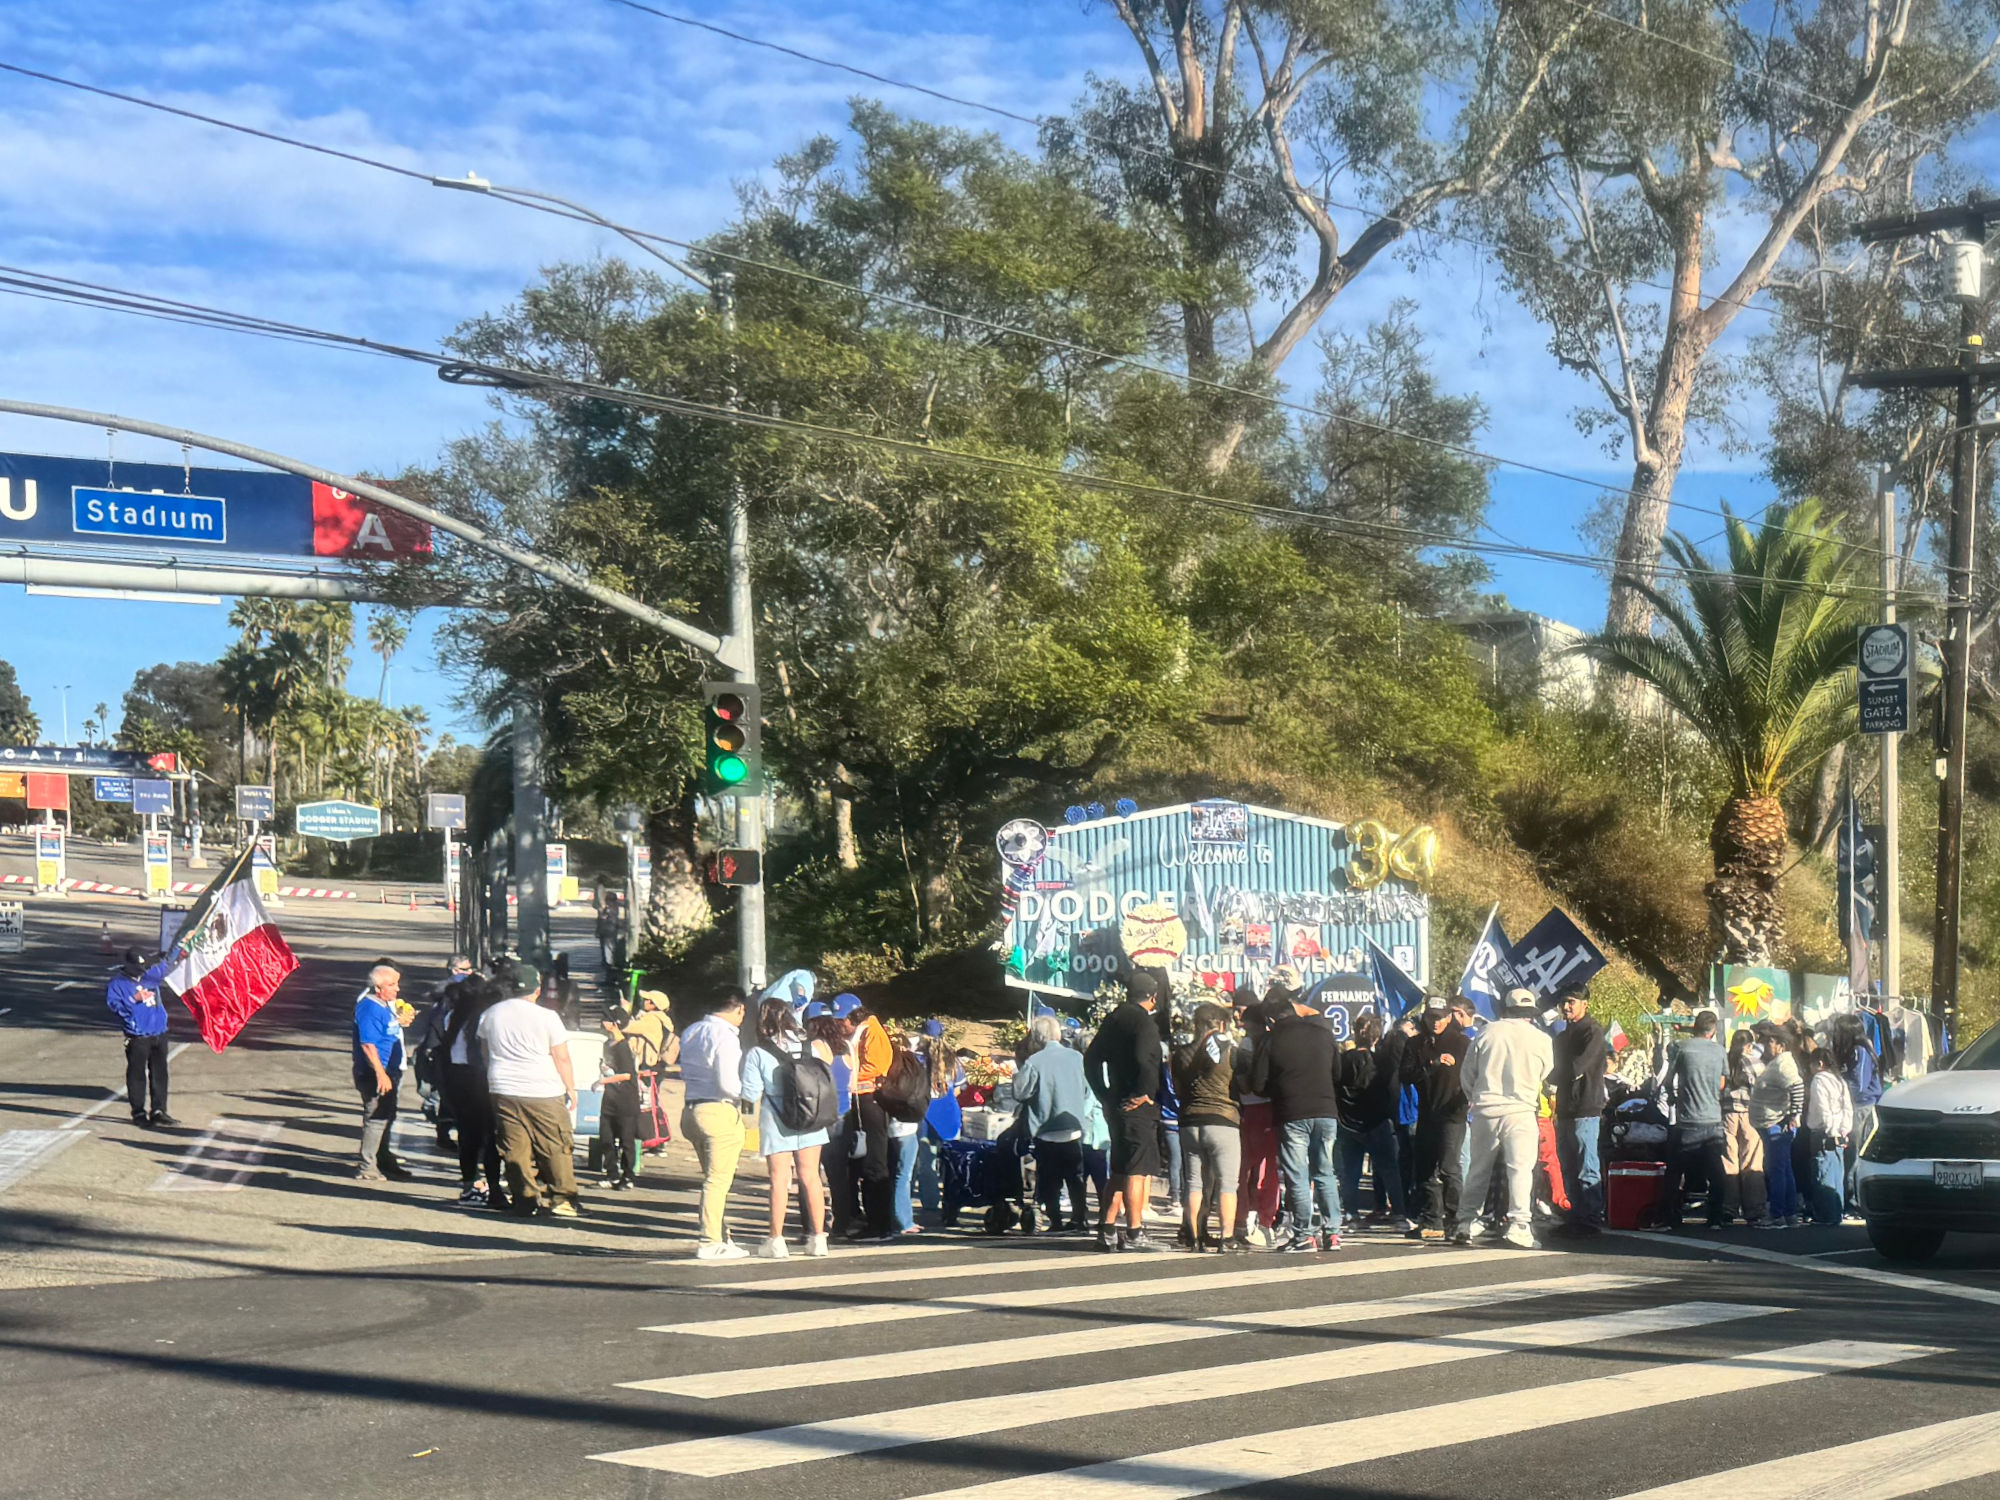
[592,1302,1790,1478]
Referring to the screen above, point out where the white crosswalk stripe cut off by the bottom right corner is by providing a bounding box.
[1622,1412,2000,1500]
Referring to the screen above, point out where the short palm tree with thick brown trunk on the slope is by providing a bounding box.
[1582,500,1866,964]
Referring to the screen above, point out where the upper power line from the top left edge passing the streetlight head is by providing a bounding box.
[0,55,1920,568]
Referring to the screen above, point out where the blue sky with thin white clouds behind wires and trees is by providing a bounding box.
[0,0,1768,738]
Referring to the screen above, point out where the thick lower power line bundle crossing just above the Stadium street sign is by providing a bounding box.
[0,266,1910,598]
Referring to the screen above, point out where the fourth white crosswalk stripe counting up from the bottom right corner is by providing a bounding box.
[620,1274,1666,1400]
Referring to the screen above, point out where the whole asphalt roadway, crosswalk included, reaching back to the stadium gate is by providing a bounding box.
[0,902,2000,1500]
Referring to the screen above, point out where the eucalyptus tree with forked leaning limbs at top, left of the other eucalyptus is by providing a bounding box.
[1046,0,1588,472]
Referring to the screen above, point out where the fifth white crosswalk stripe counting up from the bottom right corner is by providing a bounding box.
[642,1250,1550,1338]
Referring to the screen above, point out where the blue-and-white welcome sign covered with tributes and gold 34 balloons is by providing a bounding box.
[998,800,1430,998]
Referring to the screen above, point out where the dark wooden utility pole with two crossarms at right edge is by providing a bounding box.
[1850,198,2000,1048]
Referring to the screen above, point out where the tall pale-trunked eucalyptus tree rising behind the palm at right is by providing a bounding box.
[1474,0,2000,652]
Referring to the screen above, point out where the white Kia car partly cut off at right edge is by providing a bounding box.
[1854,1026,2000,1260]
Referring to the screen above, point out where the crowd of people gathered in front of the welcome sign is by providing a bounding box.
[324,956,1880,1260]
